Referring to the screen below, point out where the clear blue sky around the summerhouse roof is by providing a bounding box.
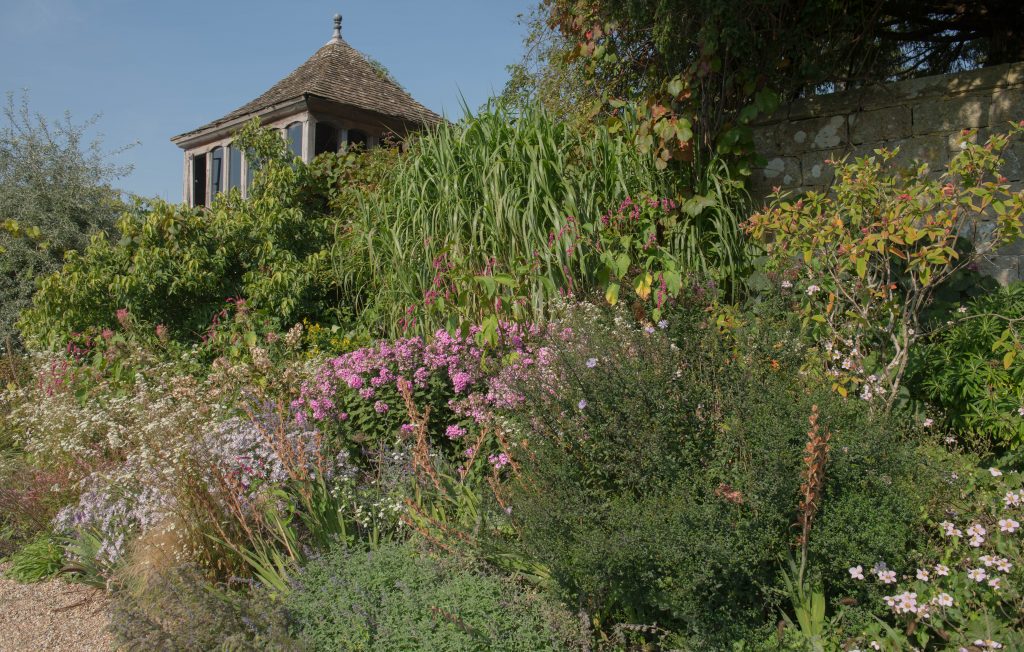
[0,0,536,202]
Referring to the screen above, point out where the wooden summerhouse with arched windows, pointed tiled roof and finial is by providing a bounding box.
[171,15,440,206]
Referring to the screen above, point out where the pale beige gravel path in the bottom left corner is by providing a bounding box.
[0,565,113,652]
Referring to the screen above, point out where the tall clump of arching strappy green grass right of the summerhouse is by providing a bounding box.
[344,106,746,336]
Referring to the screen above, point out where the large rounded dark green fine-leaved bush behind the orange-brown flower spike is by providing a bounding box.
[497,302,932,646]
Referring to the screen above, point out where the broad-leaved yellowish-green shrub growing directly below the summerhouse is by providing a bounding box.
[20,118,380,346]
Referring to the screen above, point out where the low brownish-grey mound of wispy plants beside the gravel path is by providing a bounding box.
[111,566,301,652]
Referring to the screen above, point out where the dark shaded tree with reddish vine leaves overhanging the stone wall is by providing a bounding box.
[538,0,1024,166]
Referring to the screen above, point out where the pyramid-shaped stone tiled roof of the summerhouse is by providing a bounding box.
[174,38,440,139]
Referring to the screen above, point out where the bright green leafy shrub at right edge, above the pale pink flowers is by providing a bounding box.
[907,284,1024,450]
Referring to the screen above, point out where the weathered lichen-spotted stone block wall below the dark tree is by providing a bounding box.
[752,62,1024,282]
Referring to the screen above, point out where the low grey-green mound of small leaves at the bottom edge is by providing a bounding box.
[286,545,578,652]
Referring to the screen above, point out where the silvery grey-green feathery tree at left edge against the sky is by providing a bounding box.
[0,93,131,350]
